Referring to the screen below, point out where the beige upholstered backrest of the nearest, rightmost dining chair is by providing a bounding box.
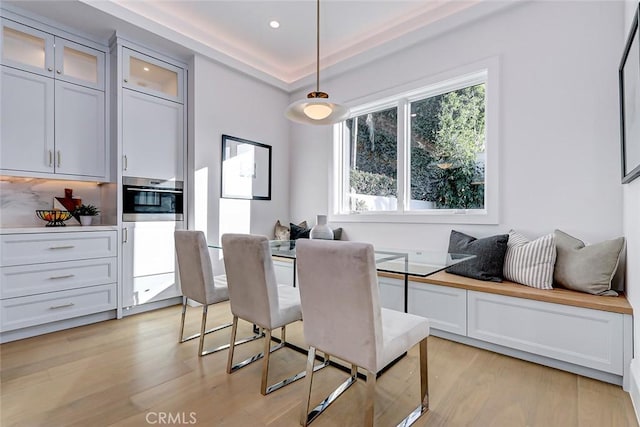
[296,239,383,372]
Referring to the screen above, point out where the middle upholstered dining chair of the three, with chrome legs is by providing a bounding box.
[222,234,328,395]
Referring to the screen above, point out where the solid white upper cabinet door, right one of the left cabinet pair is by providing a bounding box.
[55,81,106,180]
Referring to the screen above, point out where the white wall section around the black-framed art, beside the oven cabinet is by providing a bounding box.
[190,56,289,247]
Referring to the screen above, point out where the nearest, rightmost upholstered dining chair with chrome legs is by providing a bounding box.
[296,240,429,426]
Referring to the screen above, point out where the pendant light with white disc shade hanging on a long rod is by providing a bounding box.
[284,0,349,125]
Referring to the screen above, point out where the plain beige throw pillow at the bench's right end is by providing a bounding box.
[553,230,624,296]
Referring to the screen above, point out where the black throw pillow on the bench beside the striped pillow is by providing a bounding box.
[447,230,509,282]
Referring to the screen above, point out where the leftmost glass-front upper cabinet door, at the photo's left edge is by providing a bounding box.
[0,18,54,77]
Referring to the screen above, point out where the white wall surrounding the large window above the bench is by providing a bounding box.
[291,2,624,250]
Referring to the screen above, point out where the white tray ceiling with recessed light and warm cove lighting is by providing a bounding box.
[5,0,509,90]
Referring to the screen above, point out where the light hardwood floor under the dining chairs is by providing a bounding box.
[0,303,638,427]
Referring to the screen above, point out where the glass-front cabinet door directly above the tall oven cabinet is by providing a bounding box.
[122,48,184,103]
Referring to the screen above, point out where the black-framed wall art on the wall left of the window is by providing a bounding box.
[220,135,271,200]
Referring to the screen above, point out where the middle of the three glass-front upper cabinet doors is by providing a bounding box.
[55,37,105,90]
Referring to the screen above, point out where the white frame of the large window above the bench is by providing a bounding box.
[329,57,500,224]
